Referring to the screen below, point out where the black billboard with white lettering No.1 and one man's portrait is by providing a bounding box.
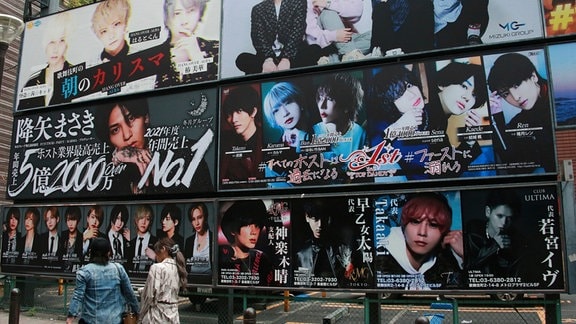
[7,90,217,200]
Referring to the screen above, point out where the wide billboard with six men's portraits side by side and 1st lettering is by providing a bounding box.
[218,48,556,190]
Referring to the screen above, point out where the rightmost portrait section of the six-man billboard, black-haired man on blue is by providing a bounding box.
[483,49,556,175]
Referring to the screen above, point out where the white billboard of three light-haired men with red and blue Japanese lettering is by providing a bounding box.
[14,0,221,111]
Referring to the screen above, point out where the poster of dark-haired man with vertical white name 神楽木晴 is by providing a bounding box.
[217,199,291,287]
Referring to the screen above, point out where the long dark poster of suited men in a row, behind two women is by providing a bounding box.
[2,201,215,284]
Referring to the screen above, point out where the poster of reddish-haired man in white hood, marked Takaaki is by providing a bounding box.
[372,191,466,290]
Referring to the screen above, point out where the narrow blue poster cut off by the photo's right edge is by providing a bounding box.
[548,43,576,128]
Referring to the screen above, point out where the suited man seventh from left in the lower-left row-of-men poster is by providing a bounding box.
[129,205,157,272]
